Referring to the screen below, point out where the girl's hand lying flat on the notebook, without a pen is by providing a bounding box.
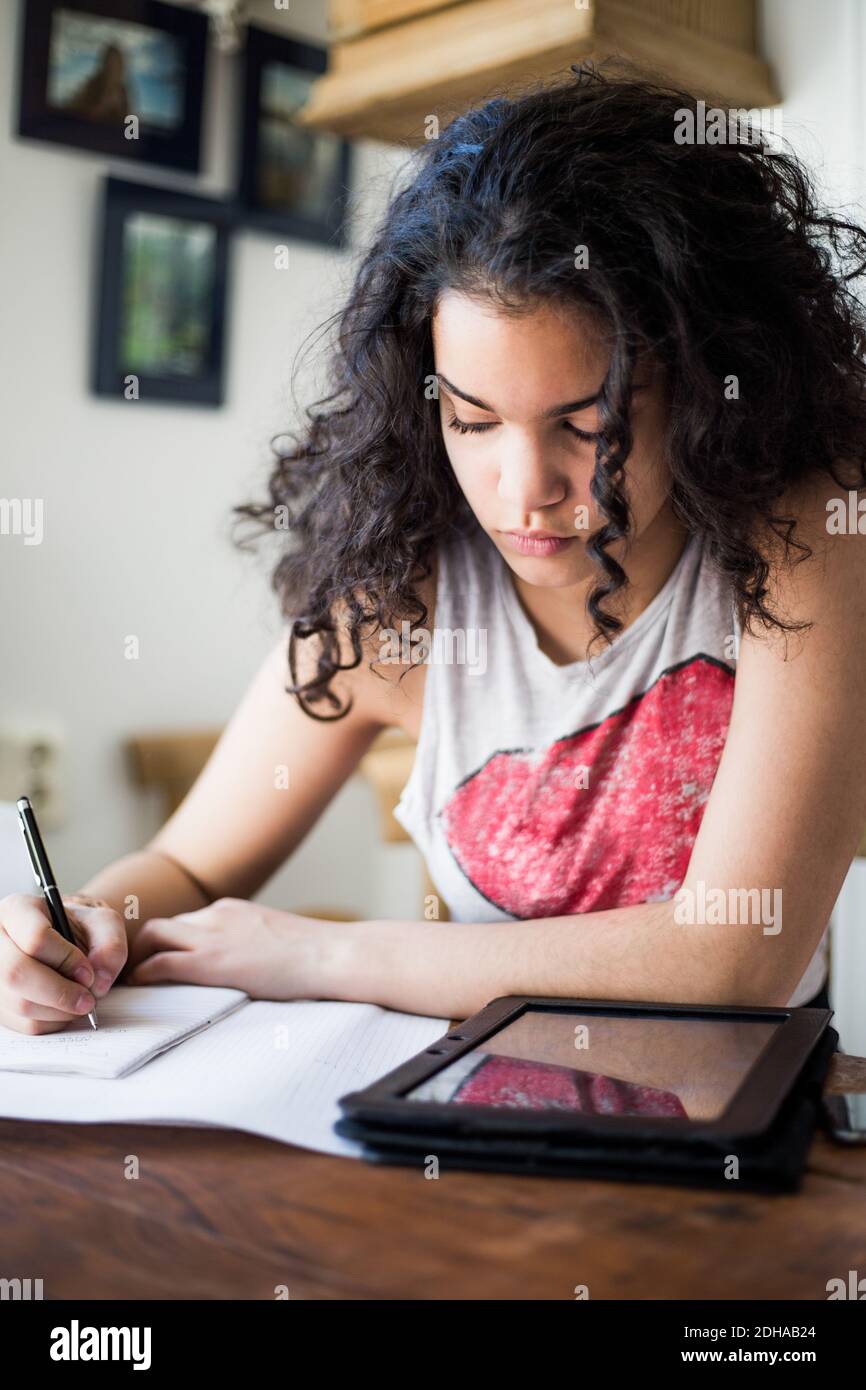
[118,898,343,999]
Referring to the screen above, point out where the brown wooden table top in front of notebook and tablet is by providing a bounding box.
[0,1055,866,1300]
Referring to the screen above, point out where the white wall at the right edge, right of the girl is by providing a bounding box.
[760,0,866,1056]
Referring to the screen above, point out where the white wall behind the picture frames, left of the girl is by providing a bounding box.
[0,0,421,916]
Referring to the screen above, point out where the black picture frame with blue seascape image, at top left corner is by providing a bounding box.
[18,0,209,174]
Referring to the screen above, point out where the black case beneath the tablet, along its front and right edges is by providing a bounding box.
[334,1026,838,1193]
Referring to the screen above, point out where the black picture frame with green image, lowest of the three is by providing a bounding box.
[92,177,232,406]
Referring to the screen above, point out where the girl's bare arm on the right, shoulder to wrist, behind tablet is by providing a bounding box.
[323,484,866,1017]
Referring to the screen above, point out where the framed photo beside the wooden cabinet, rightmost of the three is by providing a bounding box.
[238,25,350,246]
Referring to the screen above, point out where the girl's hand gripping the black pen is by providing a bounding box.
[0,892,128,1034]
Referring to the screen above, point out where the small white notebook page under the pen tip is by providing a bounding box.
[0,984,249,1080]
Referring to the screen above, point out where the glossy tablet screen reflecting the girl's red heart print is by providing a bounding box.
[405,1008,781,1120]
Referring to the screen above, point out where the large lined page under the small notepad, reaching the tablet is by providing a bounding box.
[0,986,449,1156]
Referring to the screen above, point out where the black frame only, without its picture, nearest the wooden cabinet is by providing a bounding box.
[238,25,352,247]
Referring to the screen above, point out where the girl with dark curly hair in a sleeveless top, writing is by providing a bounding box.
[0,68,866,1033]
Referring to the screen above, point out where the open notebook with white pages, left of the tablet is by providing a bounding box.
[0,984,449,1158]
